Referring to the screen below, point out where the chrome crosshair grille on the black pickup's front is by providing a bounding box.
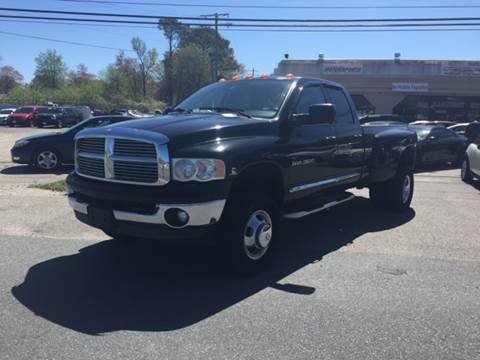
[75,136,170,185]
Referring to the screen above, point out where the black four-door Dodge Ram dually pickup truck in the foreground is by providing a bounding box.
[67,78,417,273]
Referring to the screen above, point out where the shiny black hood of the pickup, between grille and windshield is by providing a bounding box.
[108,114,272,146]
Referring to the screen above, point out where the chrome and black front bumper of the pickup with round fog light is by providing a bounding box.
[67,174,231,239]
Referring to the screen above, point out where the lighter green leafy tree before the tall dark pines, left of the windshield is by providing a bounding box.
[173,45,210,102]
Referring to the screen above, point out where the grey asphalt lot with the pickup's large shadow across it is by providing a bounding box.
[0,128,480,359]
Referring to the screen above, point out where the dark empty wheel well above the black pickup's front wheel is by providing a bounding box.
[231,164,284,206]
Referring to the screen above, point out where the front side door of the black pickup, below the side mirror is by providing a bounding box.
[287,83,336,197]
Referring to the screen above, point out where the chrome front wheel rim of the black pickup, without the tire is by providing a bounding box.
[243,210,273,260]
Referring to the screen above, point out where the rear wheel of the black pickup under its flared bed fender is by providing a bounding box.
[370,169,415,212]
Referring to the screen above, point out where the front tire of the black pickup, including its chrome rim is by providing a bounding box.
[218,193,280,275]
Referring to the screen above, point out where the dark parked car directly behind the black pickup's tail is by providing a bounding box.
[409,125,468,165]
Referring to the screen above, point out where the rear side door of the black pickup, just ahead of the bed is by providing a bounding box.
[325,85,365,183]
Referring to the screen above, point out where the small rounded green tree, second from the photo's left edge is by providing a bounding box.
[33,50,67,89]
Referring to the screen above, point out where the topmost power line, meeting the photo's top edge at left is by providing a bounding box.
[51,0,480,10]
